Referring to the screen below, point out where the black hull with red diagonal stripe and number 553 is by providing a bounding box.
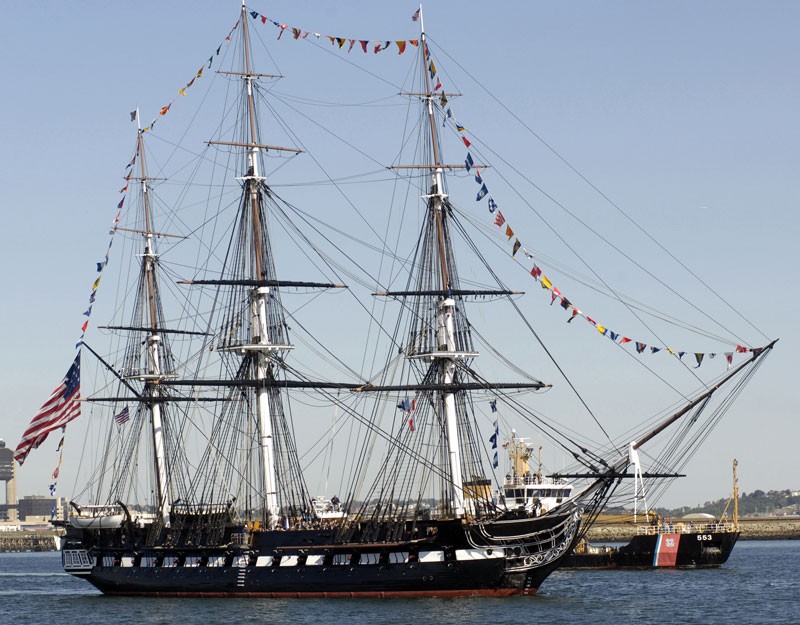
[563,532,739,569]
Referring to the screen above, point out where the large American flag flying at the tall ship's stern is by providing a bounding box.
[14,353,81,466]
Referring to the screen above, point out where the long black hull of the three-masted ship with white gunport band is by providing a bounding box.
[62,512,580,598]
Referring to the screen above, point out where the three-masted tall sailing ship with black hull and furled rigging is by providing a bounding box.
[14,5,771,597]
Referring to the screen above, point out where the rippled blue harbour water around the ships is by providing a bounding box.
[0,541,800,625]
